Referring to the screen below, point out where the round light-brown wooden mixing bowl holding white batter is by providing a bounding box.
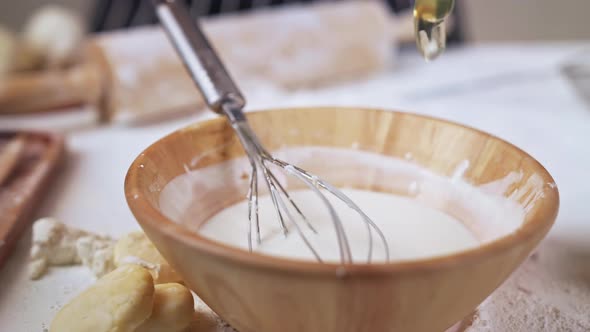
[125,108,559,332]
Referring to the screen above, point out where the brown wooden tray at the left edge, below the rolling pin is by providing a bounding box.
[0,132,64,267]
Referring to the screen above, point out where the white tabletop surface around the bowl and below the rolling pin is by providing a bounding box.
[0,43,590,332]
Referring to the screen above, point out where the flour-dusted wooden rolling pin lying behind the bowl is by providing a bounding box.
[0,1,413,122]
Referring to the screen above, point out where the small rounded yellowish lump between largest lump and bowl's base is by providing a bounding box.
[136,283,195,332]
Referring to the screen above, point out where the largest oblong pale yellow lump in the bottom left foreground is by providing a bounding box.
[49,265,154,332]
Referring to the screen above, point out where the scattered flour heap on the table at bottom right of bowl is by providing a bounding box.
[465,240,590,332]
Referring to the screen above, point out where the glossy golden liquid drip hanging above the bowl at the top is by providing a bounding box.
[414,0,455,61]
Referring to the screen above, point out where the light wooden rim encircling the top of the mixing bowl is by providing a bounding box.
[124,106,560,277]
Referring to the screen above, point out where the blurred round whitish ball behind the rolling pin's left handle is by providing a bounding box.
[23,5,85,67]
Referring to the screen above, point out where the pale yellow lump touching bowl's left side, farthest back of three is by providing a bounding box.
[115,232,182,284]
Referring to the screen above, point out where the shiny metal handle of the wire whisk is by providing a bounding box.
[153,0,246,114]
